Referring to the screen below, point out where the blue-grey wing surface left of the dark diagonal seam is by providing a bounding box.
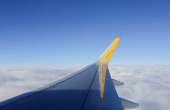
[0,64,97,110]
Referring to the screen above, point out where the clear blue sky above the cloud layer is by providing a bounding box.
[0,0,170,65]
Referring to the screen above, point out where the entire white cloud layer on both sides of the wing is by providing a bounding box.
[0,64,170,110]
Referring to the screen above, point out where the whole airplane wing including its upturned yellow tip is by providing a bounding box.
[0,38,139,110]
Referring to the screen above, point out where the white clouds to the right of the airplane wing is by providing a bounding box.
[109,64,170,110]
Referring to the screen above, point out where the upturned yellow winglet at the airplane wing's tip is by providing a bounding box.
[101,38,120,61]
